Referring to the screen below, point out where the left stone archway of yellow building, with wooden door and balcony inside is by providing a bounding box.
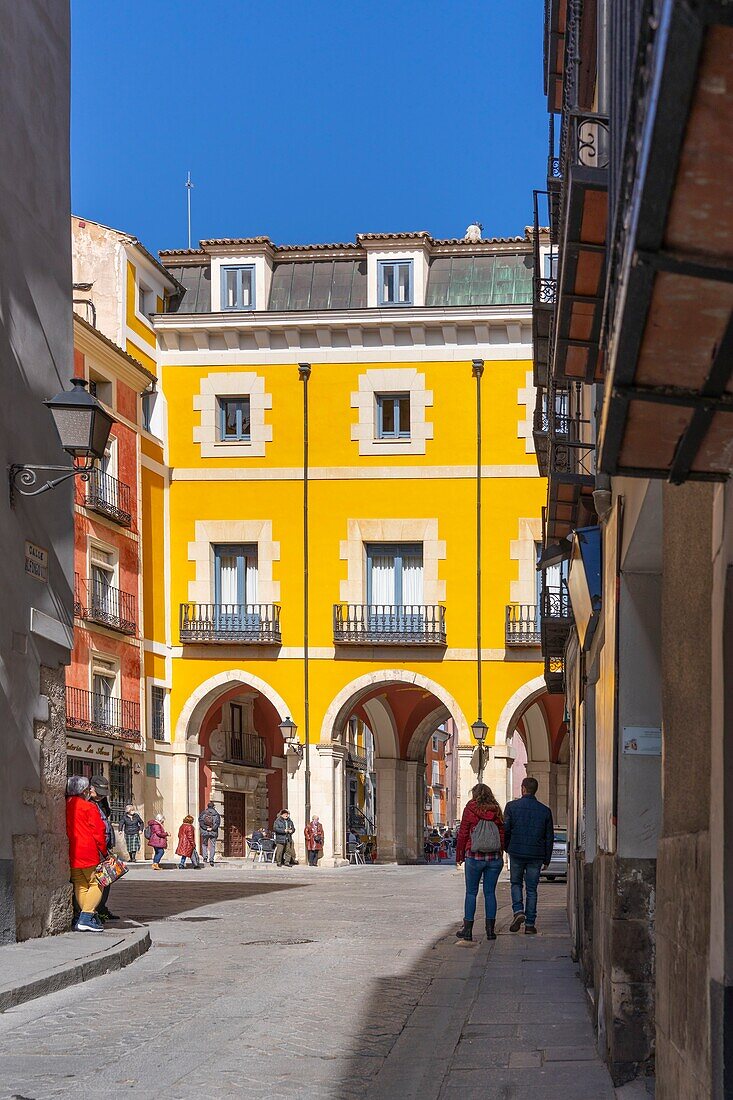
[176,670,288,857]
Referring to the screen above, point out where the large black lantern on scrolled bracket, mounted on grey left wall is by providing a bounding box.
[8,378,114,507]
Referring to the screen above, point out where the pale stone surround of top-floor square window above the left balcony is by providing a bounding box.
[194,371,272,459]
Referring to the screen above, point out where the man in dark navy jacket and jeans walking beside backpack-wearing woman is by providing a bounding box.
[504,776,555,934]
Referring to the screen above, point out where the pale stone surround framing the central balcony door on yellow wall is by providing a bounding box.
[340,519,446,604]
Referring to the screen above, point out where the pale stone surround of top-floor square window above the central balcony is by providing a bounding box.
[351,367,433,455]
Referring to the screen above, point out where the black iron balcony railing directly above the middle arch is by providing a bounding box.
[333,604,446,646]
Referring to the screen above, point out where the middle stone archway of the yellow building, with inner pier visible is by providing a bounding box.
[319,669,468,862]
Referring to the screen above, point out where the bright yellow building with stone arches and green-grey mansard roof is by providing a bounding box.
[135,233,545,862]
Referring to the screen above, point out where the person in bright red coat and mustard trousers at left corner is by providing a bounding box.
[66,776,107,932]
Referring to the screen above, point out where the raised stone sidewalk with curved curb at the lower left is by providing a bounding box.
[0,925,151,1012]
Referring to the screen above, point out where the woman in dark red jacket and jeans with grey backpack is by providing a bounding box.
[456,783,504,941]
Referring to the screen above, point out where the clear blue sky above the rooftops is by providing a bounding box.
[72,0,547,251]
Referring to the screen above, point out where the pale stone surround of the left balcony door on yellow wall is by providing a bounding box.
[188,519,280,604]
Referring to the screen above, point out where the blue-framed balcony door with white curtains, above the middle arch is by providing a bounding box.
[367,542,425,634]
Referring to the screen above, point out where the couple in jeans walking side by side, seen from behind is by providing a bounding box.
[456,777,555,941]
